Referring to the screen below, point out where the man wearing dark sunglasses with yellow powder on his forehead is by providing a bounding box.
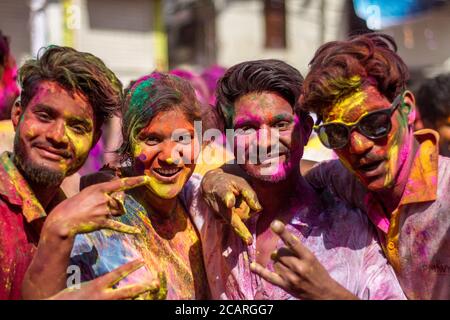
[301,33,450,299]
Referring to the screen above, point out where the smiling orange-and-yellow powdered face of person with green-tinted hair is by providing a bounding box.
[132,108,199,199]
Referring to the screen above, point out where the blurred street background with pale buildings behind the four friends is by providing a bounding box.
[0,0,450,181]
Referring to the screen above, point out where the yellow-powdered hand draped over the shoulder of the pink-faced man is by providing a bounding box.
[202,169,262,245]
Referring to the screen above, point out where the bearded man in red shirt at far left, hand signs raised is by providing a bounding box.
[0,46,156,299]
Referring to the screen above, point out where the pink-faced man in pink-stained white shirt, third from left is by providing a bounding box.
[185,60,404,299]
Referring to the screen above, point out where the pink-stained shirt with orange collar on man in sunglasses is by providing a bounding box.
[306,129,450,300]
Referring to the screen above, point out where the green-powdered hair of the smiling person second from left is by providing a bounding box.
[118,72,202,158]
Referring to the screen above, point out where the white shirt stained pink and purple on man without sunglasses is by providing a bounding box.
[183,175,405,300]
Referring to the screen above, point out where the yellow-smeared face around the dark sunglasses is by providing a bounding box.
[323,86,415,191]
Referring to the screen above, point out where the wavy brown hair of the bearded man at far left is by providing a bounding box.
[19,46,122,129]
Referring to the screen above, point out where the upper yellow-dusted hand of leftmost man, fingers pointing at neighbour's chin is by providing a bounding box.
[43,176,148,238]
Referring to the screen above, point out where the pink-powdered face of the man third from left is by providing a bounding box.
[233,92,309,182]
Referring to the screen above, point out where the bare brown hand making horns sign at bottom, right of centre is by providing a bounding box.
[250,220,357,300]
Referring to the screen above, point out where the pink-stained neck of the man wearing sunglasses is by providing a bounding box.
[375,136,419,214]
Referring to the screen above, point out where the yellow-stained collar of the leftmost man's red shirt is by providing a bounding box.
[0,152,47,223]
